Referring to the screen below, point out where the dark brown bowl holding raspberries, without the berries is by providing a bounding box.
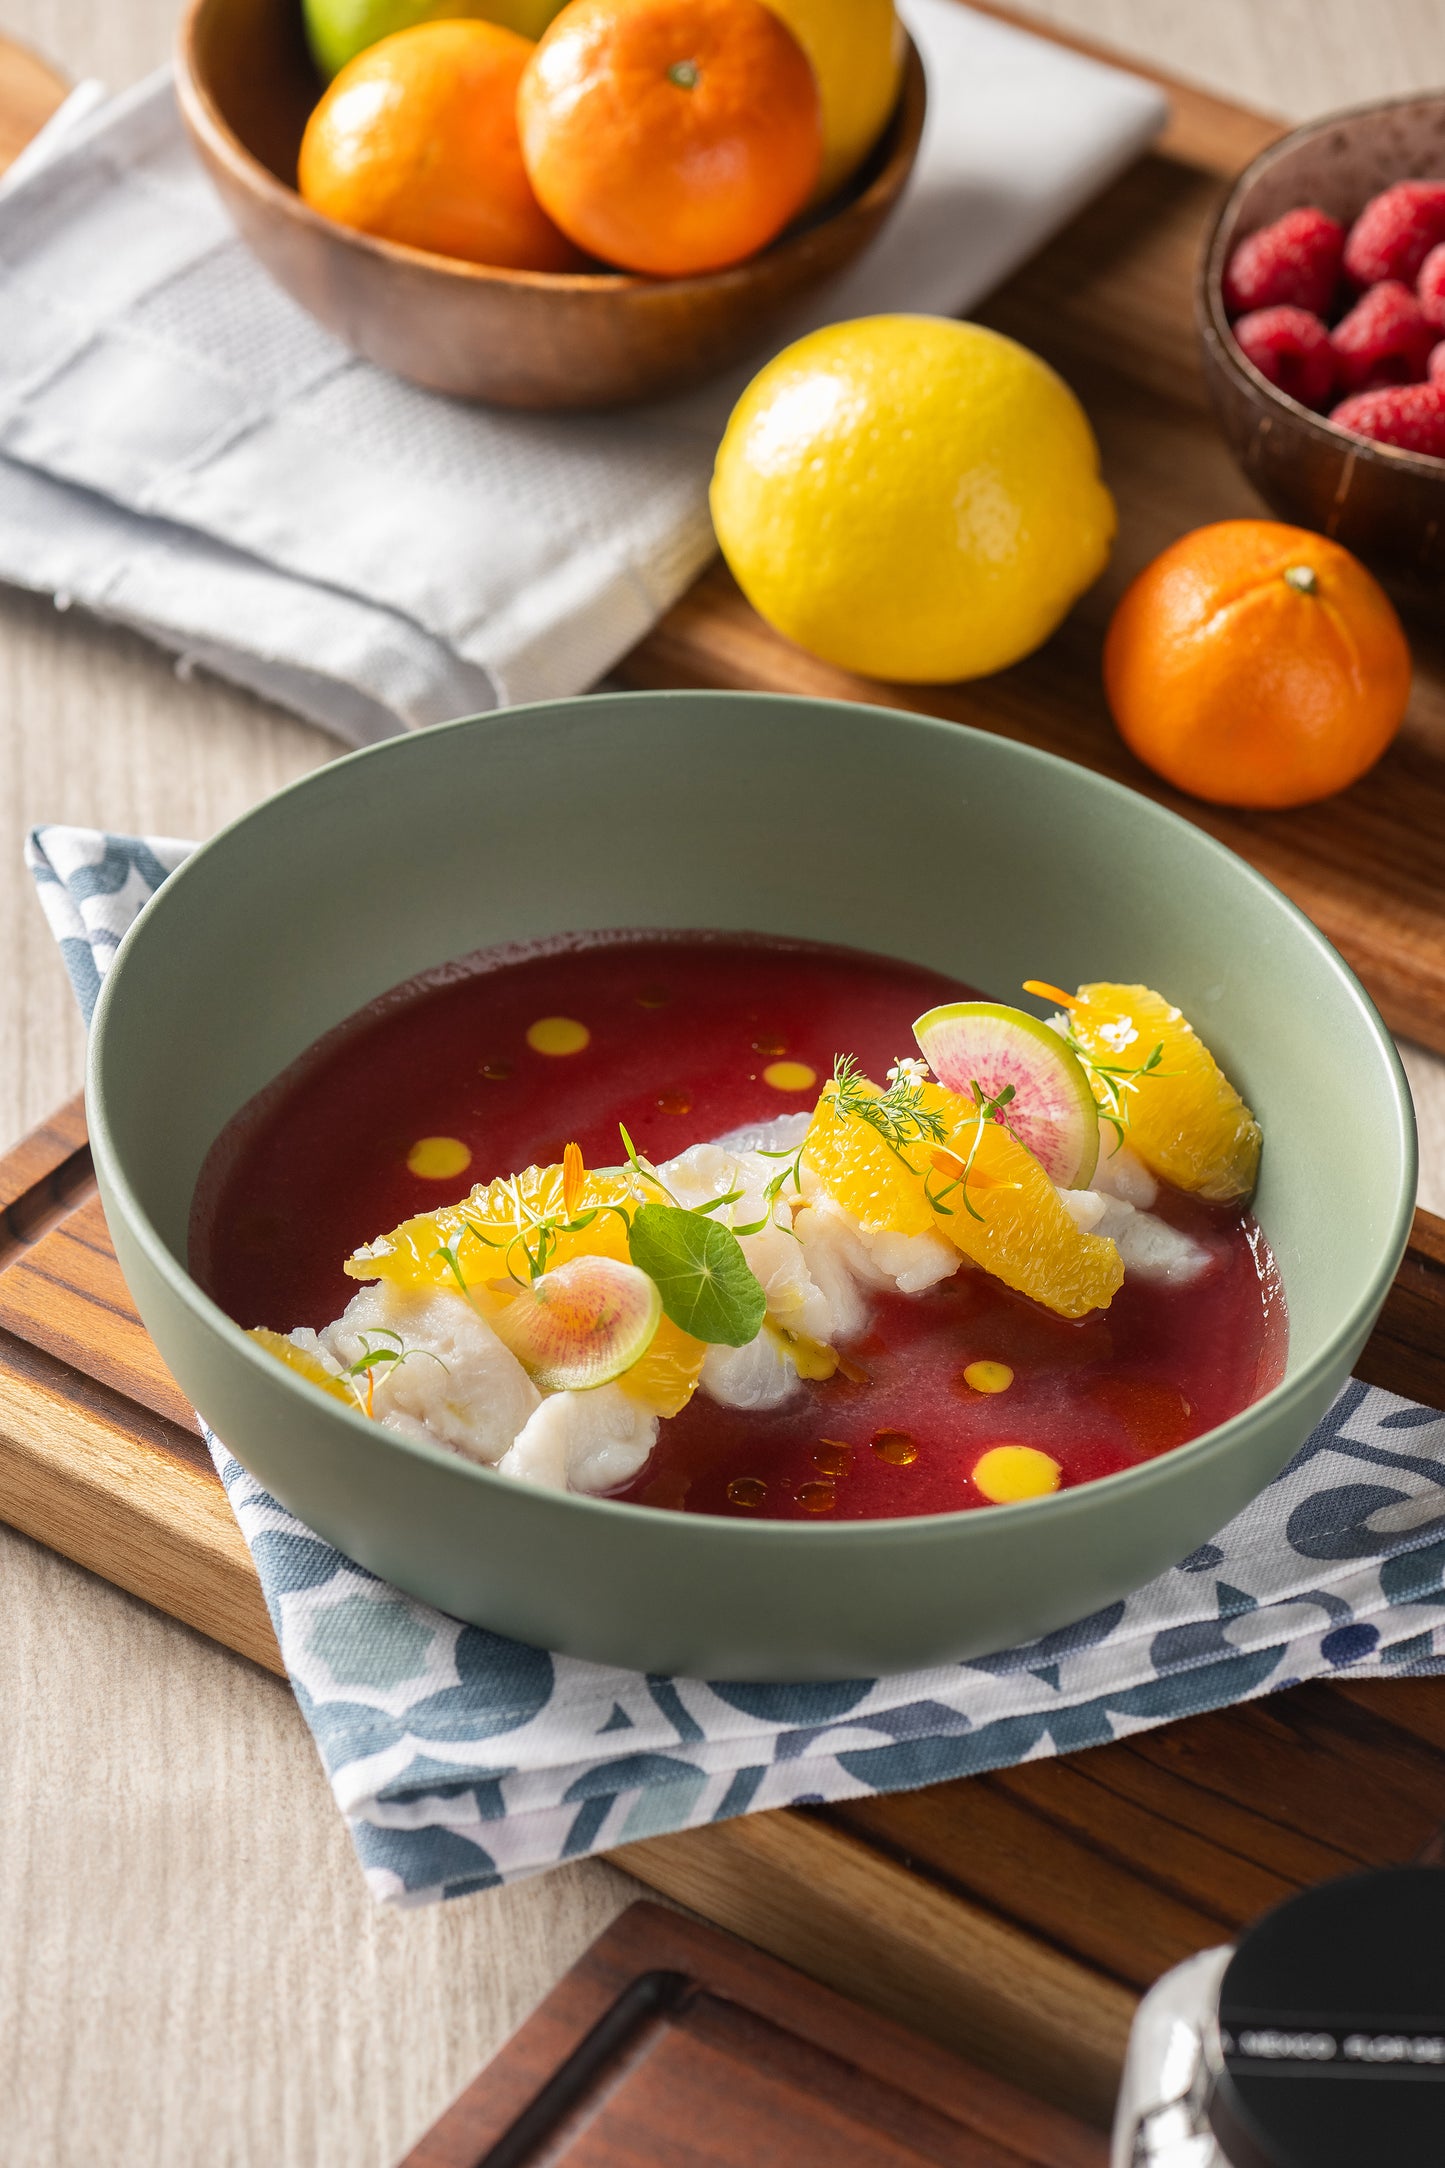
[1196,93,1445,583]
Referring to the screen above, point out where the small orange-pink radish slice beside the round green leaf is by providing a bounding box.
[490,1257,663,1392]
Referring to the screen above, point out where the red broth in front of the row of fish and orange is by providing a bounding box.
[632,1192,1285,1520]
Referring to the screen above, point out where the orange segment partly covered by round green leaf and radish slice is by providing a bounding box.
[347,1156,706,1416]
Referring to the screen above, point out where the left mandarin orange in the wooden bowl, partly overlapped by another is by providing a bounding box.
[297,22,583,271]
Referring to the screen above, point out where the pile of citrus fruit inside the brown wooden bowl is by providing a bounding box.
[297,0,903,278]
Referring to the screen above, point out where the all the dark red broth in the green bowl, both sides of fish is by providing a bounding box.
[191,932,1285,1520]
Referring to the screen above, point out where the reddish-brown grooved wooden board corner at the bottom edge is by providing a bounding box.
[401,1904,1107,2168]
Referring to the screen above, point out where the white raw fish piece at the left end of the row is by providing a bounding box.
[318,1279,542,1466]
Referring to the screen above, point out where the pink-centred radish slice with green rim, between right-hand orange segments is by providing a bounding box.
[914,1002,1098,1190]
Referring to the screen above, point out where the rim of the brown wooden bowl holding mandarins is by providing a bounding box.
[173,0,927,297]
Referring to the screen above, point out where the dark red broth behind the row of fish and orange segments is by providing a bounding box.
[191,932,973,1331]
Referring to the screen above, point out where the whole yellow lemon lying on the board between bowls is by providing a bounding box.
[711,317,1116,685]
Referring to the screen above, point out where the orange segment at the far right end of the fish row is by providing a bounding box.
[1070,982,1261,1203]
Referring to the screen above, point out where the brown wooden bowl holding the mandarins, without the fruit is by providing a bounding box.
[175,0,927,408]
